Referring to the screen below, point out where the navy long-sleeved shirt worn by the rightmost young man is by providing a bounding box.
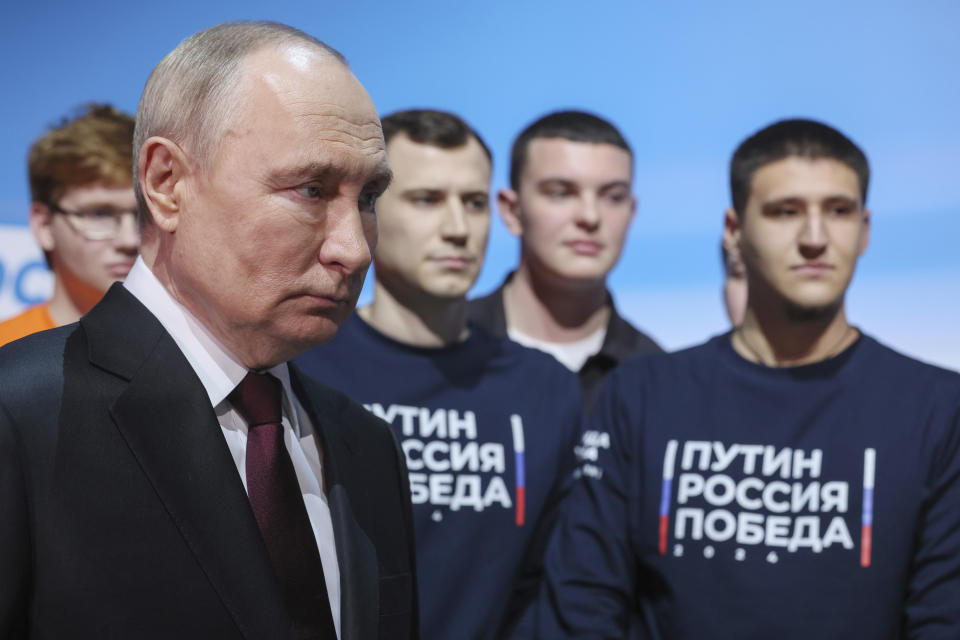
[540,334,960,640]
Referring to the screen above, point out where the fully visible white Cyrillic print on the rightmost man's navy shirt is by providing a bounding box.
[658,440,876,567]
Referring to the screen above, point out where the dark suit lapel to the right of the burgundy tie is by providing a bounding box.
[290,365,380,640]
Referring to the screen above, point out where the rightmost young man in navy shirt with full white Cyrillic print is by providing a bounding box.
[538,120,960,640]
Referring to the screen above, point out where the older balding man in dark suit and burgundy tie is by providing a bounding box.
[0,23,418,640]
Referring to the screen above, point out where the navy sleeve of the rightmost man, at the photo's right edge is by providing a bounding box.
[904,393,960,640]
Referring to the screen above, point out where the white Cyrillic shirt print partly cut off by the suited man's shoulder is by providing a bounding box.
[364,403,526,527]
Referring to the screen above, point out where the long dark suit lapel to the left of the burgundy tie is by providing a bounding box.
[81,285,295,638]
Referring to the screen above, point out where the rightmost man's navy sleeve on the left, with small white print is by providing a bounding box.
[537,372,639,638]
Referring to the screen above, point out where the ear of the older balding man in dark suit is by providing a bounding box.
[137,136,190,233]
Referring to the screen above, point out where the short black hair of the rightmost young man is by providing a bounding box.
[730,119,870,216]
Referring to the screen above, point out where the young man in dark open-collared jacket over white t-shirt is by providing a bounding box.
[470,111,661,407]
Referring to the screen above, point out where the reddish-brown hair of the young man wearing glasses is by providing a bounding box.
[27,104,133,205]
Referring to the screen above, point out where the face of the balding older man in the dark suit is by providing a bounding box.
[170,46,390,368]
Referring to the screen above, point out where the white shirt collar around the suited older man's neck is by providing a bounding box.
[123,257,299,422]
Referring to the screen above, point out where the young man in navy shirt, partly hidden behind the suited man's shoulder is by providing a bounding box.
[297,110,580,640]
